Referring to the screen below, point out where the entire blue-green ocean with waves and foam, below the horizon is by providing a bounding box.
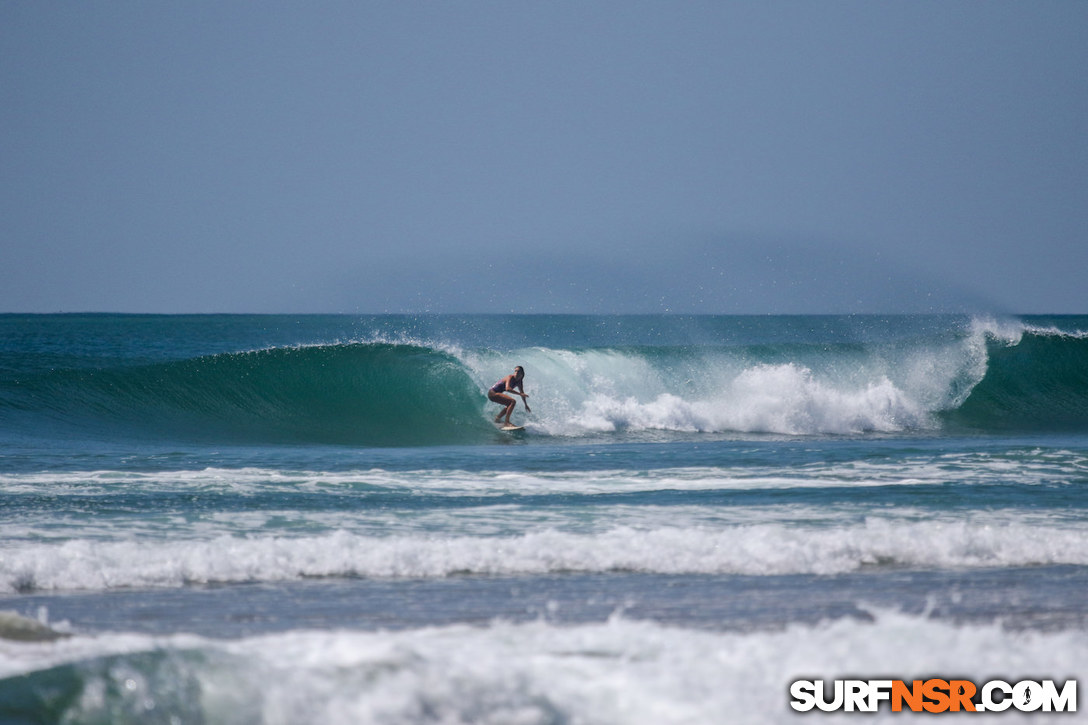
[0,315,1088,724]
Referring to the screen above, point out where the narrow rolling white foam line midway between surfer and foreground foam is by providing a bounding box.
[8,516,1088,592]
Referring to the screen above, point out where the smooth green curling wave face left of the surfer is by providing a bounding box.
[6,343,489,446]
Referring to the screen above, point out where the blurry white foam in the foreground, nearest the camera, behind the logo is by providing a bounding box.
[0,612,1088,725]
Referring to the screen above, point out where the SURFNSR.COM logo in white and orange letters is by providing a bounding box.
[790,678,1077,713]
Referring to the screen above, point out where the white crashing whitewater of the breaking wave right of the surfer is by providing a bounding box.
[460,330,996,435]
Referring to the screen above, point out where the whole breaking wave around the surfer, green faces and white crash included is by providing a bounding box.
[0,320,1088,445]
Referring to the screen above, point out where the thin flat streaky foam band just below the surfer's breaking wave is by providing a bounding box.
[0,448,1088,497]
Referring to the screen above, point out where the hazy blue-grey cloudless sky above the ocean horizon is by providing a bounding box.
[0,0,1088,314]
